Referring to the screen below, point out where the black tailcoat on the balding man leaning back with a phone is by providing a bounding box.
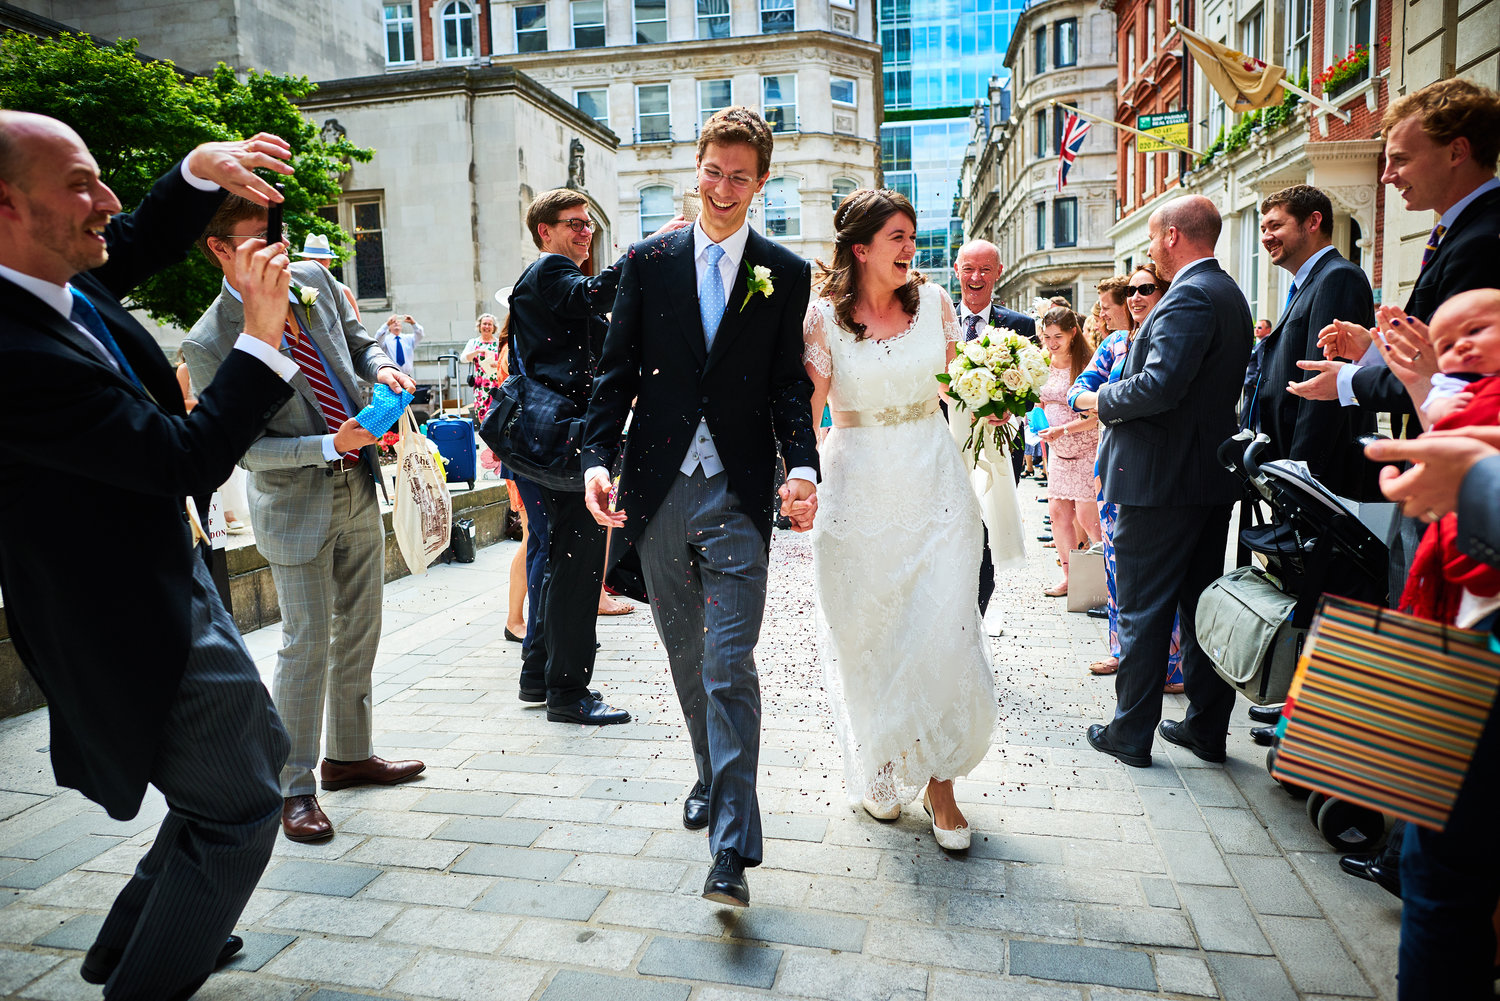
[0,168,293,819]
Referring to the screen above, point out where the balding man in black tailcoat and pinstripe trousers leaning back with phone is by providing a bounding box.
[0,111,296,1001]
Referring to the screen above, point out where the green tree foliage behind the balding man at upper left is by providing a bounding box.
[0,33,375,329]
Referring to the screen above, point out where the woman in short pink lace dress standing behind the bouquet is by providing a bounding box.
[1041,306,1100,597]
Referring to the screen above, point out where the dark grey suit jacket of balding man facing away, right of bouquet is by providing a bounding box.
[1098,260,1254,507]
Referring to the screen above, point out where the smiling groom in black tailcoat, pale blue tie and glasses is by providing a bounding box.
[584,107,818,906]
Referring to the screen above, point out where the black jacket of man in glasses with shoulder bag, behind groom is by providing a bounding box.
[510,254,620,414]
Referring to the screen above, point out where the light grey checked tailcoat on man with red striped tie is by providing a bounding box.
[183,261,396,566]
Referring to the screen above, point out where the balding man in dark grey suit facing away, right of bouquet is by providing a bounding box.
[1077,195,1254,768]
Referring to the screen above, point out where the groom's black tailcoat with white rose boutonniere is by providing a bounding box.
[584,227,818,545]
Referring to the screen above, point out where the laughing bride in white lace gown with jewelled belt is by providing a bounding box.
[804,191,1013,849]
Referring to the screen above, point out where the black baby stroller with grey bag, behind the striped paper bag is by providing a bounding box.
[1196,431,1397,852]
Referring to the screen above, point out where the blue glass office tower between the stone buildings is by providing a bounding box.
[881,0,1026,290]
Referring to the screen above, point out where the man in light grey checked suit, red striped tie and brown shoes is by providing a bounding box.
[183,198,425,840]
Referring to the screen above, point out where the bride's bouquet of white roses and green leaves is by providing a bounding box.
[938,327,1047,462]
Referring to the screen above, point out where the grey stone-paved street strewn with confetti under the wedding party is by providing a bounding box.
[0,480,1398,1001]
